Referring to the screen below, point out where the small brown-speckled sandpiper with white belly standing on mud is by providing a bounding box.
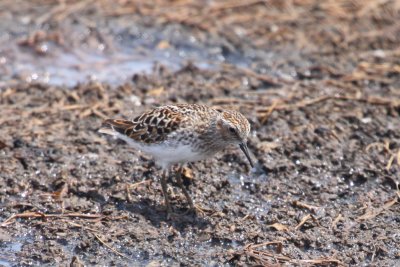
[99,104,253,217]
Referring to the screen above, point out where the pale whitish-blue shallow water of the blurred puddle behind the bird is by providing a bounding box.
[1,48,165,87]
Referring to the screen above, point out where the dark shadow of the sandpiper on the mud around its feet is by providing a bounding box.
[116,198,210,231]
